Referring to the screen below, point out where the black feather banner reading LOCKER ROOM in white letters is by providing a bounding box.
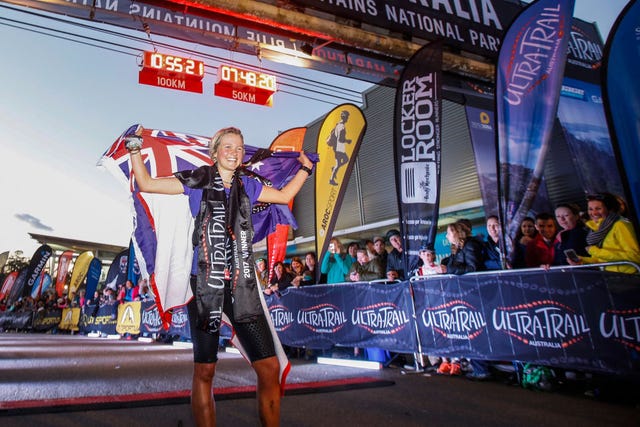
[393,43,442,272]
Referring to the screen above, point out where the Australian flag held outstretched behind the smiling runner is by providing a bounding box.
[98,125,318,330]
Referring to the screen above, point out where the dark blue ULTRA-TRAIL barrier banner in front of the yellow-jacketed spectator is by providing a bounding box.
[414,270,640,373]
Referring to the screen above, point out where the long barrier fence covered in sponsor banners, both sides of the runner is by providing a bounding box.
[0,267,640,374]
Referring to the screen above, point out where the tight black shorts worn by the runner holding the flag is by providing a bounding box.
[187,277,276,363]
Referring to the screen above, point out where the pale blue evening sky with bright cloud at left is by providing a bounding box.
[0,0,626,257]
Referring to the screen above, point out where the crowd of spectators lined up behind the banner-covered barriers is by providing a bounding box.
[0,193,640,392]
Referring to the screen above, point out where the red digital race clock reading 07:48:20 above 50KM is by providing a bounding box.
[214,64,277,107]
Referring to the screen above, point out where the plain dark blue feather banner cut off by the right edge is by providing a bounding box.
[604,1,640,233]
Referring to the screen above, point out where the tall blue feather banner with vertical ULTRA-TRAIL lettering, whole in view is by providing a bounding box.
[496,0,574,249]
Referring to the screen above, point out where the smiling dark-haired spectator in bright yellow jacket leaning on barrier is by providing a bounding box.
[567,193,640,273]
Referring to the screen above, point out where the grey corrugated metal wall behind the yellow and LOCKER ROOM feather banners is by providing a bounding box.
[294,86,481,241]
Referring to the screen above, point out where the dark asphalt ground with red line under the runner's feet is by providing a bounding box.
[0,333,640,427]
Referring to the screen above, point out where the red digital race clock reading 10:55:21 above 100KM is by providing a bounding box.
[138,51,204,93]
